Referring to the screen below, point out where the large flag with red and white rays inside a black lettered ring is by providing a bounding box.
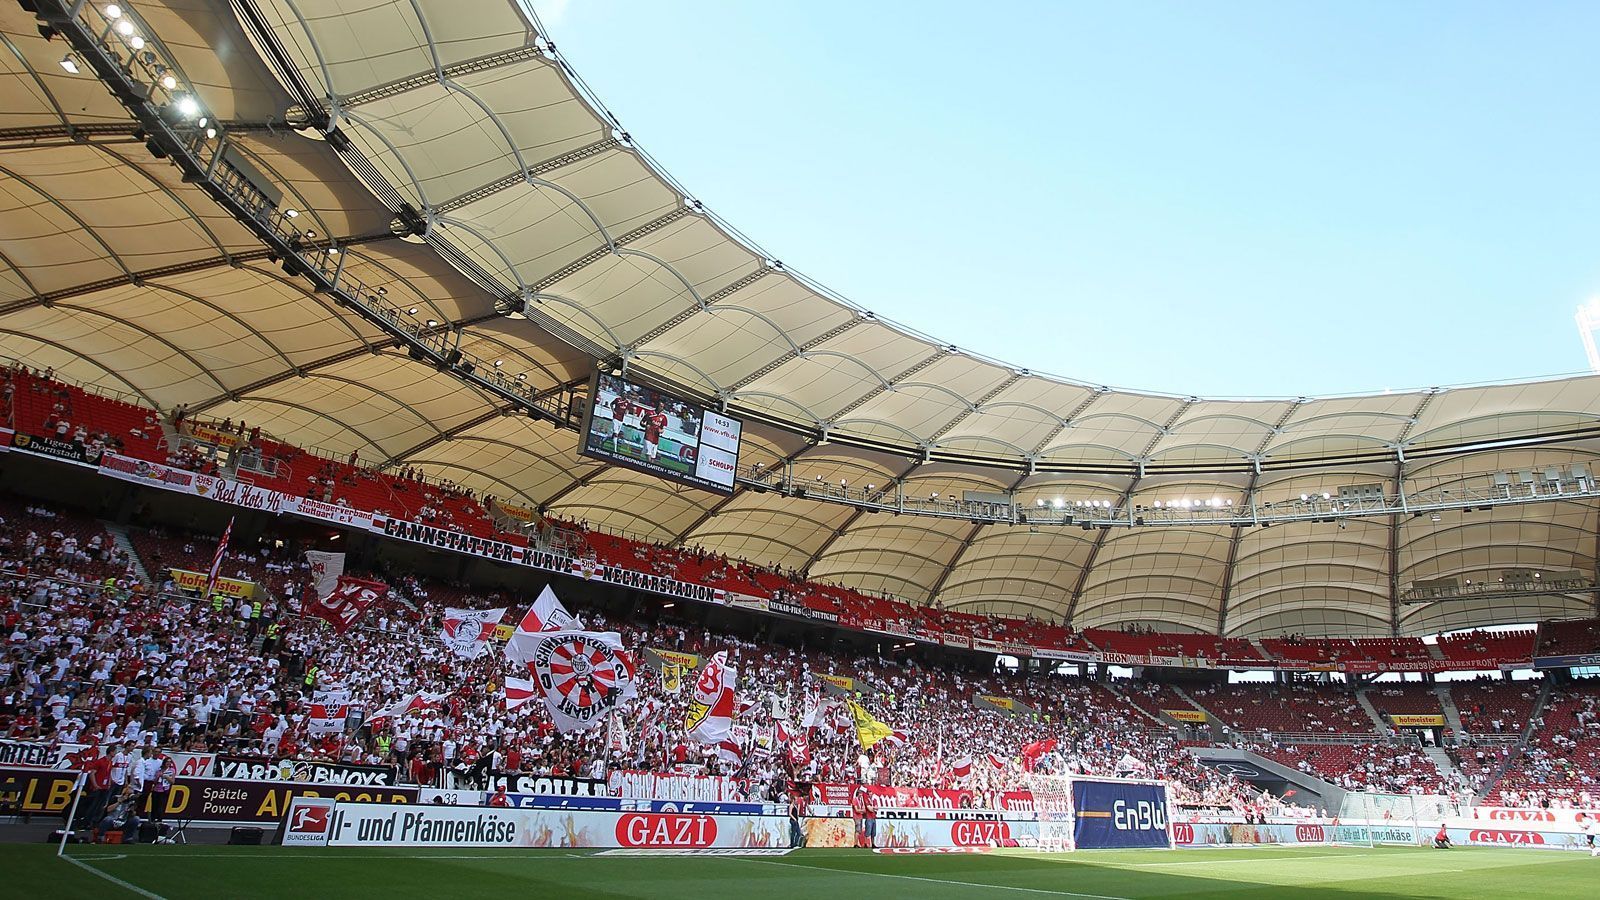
[517,631,638,733]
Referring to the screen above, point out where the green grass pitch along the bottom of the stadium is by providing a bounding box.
[9,844,1600,900]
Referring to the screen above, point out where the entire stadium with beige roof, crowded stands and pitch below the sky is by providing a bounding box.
[0,0,1600,900]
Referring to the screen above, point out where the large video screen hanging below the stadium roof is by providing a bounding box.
[582,372,742,493]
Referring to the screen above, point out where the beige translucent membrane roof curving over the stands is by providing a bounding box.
[0,0,1600,636]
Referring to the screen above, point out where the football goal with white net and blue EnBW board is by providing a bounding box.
[1029,775,1173,850]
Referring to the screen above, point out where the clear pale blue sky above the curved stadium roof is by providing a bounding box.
[534,0,1600,396]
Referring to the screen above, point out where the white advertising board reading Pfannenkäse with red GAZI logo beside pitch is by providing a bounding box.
[315,802,790,849]
